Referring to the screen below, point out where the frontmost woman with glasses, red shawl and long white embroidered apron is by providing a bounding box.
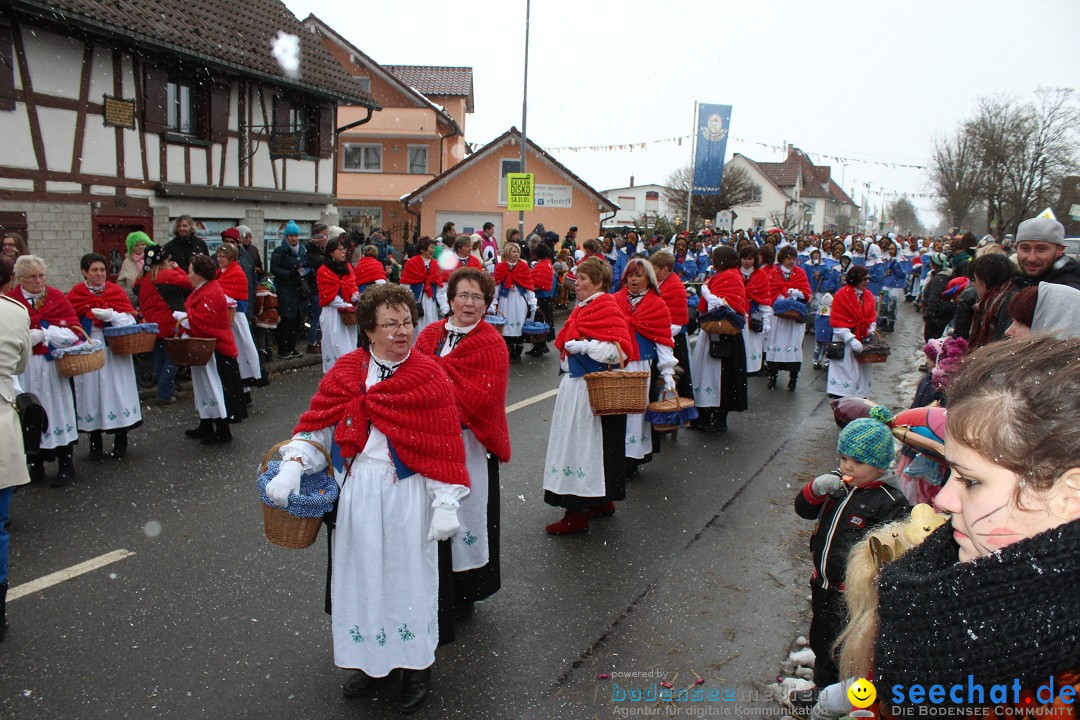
[266,284,468,714]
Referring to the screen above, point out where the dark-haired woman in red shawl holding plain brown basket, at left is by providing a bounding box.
[179,255,247,445]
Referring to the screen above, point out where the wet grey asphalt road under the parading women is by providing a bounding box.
[0,307,917,719]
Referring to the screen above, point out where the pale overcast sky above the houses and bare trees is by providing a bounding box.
[285,0,1080,225]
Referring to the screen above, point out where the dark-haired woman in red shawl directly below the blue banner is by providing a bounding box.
[690,245,750,433]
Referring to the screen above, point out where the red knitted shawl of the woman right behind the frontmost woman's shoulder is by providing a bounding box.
[416,320,510,462]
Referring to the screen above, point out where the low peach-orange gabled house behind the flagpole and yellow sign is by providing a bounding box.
[402,127,618,242]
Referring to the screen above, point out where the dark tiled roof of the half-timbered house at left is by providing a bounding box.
[9,0,378,108]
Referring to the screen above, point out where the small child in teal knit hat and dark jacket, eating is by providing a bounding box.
[795,407,908,689]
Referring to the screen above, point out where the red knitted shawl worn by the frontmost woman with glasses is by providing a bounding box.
[293,348,469,487]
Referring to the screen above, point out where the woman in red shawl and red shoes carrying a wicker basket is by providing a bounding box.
[543,258,637,535]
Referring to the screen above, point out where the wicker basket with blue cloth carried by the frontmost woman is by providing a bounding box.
[258,439,338,549]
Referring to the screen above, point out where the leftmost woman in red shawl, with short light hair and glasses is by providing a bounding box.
[8,255,83,488]
